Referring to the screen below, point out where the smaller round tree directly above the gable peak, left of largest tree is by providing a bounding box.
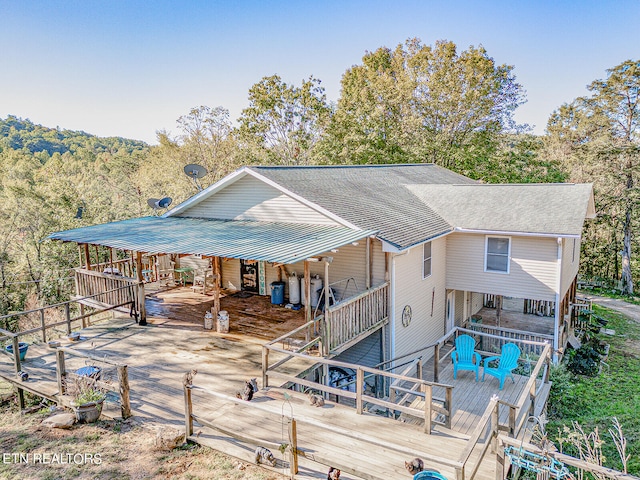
[239,75,331,165]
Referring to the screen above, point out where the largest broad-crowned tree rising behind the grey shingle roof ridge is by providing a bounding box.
[325,39,524,174]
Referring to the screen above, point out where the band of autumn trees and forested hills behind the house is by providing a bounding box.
[0,39,640,313]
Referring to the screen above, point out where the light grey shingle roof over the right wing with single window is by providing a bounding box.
[407,183,592,235]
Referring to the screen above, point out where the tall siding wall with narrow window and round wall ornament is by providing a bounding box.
[391,238,447,358]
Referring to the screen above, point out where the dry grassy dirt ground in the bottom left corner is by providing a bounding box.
[0,383,285,480]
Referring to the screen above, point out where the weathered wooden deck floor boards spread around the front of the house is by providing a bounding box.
[0,289,544,480]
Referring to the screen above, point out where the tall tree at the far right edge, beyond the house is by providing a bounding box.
[548,60,640,295]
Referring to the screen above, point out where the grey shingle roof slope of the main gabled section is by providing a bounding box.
[249,164,476,249]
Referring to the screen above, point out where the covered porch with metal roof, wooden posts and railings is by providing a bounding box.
[50,217,388,355]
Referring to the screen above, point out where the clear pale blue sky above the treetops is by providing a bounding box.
[0,0,640,143]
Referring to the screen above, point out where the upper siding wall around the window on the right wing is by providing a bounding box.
[445,233,558,301]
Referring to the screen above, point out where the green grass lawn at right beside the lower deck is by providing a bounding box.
[547,306,640,476]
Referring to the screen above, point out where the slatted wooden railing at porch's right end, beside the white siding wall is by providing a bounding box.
[324,282,389,353]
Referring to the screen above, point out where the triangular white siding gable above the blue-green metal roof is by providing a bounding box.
[178,175,338,225]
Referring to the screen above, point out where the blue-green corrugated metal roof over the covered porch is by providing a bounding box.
[48,217,376,264]
